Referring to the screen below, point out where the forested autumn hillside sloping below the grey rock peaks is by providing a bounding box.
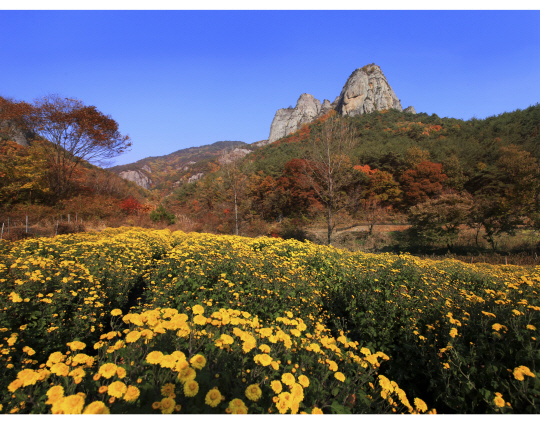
[163,105,540,252]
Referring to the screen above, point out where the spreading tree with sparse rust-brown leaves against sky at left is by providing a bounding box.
[29,95,131,197]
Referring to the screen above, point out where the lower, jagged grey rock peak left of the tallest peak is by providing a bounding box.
[268,93,321,143]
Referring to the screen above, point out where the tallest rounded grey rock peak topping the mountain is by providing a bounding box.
[336,64,403,116]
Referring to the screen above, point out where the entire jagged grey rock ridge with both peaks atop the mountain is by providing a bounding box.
[264,63,410,146]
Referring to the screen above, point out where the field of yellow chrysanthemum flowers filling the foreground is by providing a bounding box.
[0,228,540,414]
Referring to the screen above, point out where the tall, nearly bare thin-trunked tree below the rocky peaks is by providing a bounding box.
[303,115,363,244]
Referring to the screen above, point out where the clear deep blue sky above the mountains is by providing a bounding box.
[0,10,540,164]
